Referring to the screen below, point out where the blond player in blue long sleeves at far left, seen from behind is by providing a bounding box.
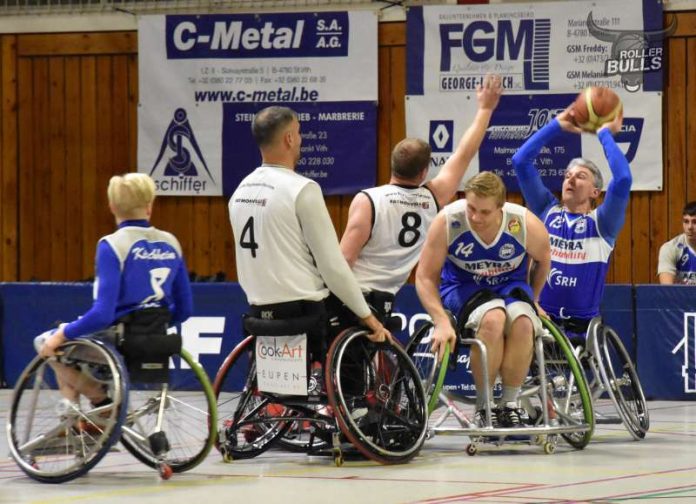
[34,173,193,406]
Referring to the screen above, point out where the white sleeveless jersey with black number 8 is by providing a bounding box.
[353,184,438,294]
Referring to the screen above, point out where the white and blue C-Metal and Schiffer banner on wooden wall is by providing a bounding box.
[138,11,378,196]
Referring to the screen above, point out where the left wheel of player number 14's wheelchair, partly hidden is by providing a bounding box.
[406,322,450,414]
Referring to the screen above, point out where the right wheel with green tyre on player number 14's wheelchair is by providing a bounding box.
[541,317,594,449]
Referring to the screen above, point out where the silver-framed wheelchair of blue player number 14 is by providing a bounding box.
[406,315,594,455]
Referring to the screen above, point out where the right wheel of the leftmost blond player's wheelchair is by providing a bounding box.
[121,350,217,473]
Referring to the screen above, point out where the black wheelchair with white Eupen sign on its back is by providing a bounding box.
[213,304,427,466]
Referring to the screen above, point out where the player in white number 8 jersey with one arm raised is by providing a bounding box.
[341,75,502,313]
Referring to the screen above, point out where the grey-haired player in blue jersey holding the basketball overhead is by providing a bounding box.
[512,106,632,335]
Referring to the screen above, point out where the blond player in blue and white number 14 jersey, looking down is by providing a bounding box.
[416,172,551,427]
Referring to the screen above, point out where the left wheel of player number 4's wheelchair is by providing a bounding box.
[213,336,292,460]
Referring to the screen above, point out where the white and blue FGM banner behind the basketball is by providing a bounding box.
[406,0,676,190]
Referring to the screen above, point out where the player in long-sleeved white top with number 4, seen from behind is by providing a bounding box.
[229,106,391,360]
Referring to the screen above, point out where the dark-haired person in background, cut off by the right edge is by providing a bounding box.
[657,201,696,285]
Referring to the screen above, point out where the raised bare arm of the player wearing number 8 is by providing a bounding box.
[428,75,503,208]
